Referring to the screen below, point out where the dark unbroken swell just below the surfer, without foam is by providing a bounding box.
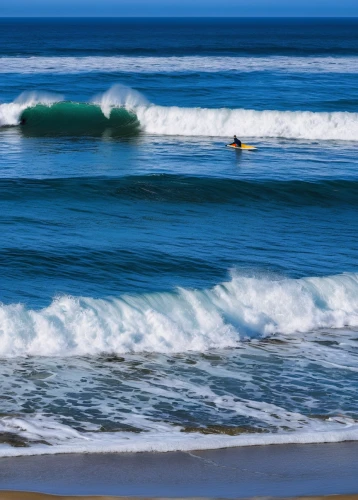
[0,174,358,206]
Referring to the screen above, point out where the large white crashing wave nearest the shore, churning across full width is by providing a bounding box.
[0,274,358,357]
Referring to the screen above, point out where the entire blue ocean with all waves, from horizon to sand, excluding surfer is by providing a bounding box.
[0,19,358,456]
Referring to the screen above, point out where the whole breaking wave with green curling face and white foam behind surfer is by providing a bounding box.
[0,85,358,141]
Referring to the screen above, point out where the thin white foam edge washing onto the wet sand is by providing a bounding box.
[0,416,358,457]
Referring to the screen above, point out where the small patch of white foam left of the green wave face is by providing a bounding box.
[0,92,62,127]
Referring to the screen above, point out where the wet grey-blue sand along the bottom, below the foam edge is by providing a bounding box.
[0,442,358,500]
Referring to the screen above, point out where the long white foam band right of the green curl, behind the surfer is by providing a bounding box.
[135,105,358,141]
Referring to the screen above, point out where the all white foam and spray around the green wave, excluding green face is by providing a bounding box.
[0,85,358,141]
